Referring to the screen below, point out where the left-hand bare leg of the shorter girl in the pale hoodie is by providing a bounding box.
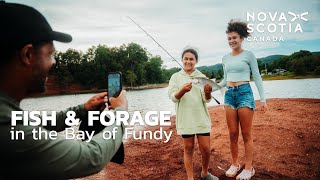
[183,137,195,180]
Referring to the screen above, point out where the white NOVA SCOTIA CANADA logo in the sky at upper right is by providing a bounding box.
[247,11,309,41]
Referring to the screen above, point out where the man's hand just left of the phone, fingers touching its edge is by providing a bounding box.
[84,92,108,111]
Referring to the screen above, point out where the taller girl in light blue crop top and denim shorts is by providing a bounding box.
[219,20,267,179]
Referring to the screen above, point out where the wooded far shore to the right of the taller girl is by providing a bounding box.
[258,50,320,75]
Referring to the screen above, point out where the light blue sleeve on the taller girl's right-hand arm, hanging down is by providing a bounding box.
[249,53,266,102]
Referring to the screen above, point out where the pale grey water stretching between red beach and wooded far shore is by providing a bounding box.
[21,78,320,115]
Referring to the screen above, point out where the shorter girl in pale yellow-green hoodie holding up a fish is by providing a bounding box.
[168,49,218,180]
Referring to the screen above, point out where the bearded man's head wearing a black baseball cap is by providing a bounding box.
[0,1,72,94]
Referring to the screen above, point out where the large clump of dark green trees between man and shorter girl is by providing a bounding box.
[52,43,179,89]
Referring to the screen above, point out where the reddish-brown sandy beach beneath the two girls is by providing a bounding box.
[82,99,320,180]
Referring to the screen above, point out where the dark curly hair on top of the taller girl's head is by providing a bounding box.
[226,19,250,38]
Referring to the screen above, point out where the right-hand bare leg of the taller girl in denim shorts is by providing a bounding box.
[238,107,254,170]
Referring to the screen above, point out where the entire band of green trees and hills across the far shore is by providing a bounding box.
[51,43,320,89]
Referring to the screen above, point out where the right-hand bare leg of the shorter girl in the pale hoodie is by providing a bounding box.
[198,136,211,176]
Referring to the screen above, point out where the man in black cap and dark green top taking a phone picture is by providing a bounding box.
[0,1,128,179]
